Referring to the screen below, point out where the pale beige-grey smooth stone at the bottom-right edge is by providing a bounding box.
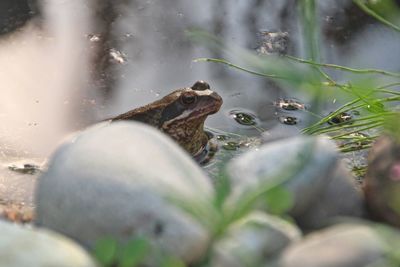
[277,223,399,267]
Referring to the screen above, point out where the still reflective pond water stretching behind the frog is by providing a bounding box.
[0,0,400,205]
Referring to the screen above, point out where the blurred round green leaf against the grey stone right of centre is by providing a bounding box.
[265,186,294,215]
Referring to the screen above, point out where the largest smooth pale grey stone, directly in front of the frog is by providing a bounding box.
[36,122,213,262]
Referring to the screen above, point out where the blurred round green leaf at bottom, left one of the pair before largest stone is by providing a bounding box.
[93,238,118,266]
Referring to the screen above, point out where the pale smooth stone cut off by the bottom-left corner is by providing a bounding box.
[0,220,97,267]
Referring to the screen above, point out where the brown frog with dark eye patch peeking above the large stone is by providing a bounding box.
[111,81,222,157]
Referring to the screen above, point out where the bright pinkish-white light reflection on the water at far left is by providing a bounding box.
[0,0,95,204]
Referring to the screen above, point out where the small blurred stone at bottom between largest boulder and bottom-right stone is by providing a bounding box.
[211,211,301,267]
